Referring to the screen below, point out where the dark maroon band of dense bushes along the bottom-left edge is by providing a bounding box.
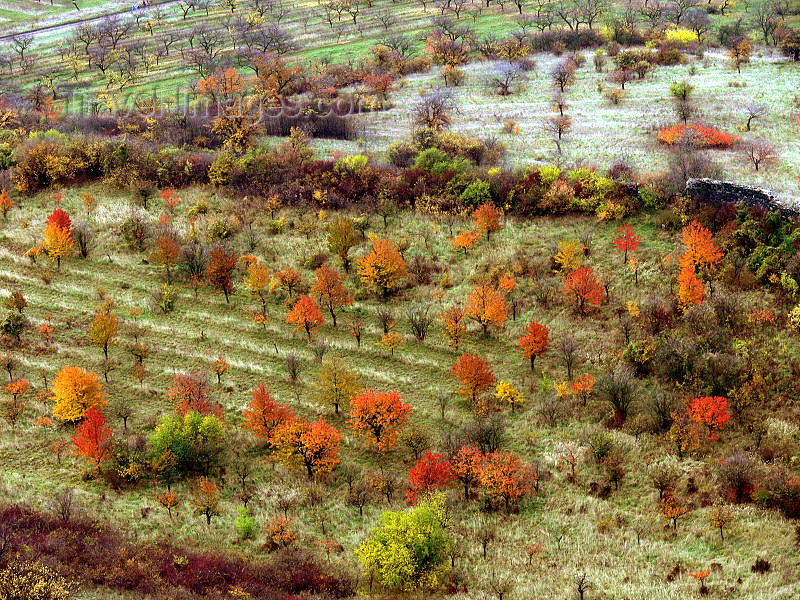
[0,506,353,600]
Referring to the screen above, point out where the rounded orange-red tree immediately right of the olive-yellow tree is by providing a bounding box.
[349,389,411,450]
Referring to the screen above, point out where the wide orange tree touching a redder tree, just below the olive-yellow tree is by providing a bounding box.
[270,419,342,479]
